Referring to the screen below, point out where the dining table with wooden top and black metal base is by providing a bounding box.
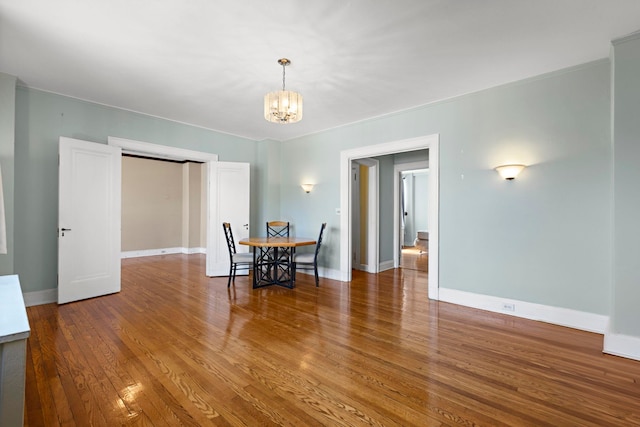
[238,237,316,289]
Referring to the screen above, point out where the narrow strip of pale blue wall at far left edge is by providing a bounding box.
[0,73,17,275]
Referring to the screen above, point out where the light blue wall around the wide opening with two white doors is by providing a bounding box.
[12,87,261,292]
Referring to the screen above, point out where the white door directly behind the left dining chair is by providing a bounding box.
[206,162,250,276]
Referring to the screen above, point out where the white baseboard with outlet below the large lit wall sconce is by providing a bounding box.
[438,288,609,334]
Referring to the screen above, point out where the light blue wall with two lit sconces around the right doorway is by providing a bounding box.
[280,60,611,314]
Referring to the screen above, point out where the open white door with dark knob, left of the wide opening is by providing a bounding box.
[58,137,122,304]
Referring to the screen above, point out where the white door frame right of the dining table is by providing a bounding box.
[340,134,440,299]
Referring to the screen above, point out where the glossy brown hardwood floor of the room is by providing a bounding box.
[25,255,640,426]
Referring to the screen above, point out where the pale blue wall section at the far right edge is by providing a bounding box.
[610,33,640,338]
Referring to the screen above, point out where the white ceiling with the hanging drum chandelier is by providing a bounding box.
[0,0,640,140]
